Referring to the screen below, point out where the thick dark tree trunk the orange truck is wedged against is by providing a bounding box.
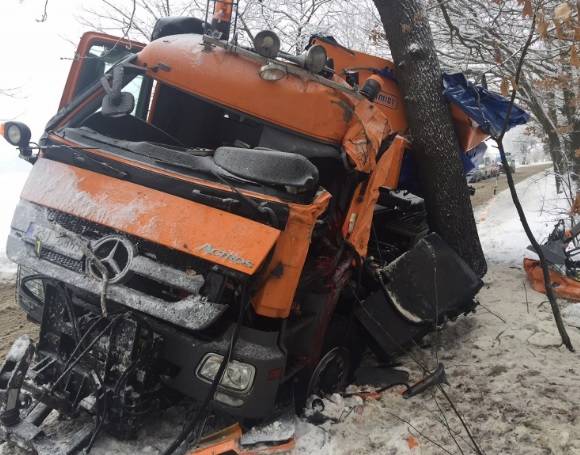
[374,0,487,276]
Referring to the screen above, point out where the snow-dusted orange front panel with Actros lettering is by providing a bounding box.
[21,158,280,275]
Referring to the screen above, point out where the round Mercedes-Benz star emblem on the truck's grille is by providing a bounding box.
[87,235,135,284]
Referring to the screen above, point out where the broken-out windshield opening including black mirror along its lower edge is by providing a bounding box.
[56,63,341,203]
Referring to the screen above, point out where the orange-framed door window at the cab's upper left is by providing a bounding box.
[59,32,145,110]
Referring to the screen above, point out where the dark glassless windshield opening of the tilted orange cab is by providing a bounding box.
[61,70,342,201]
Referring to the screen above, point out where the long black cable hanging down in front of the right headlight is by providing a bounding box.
[163,284,250,455]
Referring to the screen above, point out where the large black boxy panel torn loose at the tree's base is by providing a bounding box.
[355,234,483,356]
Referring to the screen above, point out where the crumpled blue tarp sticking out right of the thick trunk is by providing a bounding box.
[443,73,530,136]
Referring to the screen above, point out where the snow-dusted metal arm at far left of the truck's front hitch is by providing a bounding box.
[0,335,34,427]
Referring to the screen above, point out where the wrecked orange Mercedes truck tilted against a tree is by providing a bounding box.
[0,1,524,453]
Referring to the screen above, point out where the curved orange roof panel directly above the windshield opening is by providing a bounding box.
[139,35,351,143]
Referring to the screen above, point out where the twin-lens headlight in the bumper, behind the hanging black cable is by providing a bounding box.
[197,353,256,392]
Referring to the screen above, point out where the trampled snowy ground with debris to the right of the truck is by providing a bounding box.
[296,174,580,455]
